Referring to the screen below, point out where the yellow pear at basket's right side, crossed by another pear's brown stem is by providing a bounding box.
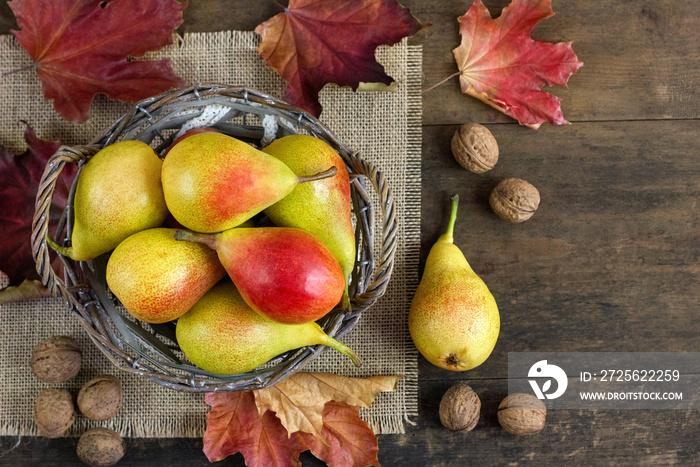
[263,135,355,306]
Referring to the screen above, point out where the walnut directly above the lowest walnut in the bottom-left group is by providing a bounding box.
[78,375,124,420]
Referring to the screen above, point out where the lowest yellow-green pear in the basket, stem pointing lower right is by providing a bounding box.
[175,280,361,375]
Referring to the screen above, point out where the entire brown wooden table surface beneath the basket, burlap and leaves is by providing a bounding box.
[0,0,700,466]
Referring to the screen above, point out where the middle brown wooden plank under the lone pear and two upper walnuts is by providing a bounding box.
[421,120,700,379]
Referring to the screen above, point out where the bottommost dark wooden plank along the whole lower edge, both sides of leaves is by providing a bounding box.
[0,380,700,467]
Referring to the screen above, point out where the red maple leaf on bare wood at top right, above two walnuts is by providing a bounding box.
[453,0,583,129]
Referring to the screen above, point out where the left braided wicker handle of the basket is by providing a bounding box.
[31,146,96,304]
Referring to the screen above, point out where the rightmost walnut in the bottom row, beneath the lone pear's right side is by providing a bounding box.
[498,393,547,436]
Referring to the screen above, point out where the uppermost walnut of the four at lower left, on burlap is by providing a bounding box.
[30,336,80,383]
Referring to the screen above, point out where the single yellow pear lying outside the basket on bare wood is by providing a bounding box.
[408,195,500,371]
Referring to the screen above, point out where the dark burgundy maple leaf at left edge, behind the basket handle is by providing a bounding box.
[0,126,76,286]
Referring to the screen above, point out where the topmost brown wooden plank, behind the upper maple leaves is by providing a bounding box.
[0,0,700,125]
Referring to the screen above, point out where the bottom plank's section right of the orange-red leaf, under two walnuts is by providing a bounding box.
[400,380,700,466]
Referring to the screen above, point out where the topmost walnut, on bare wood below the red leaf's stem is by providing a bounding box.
[452,123,498,173]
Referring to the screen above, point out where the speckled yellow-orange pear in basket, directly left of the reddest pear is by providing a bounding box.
[106,228,226,323]
